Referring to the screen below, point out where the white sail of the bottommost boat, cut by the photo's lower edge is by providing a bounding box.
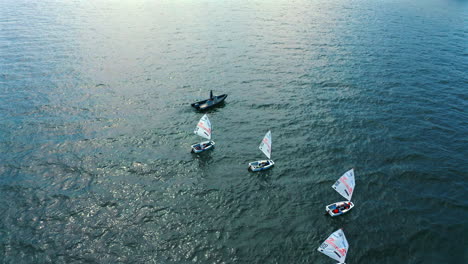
[318,229,349,263]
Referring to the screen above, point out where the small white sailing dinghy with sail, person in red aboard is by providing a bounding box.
[325,169,355,216]
